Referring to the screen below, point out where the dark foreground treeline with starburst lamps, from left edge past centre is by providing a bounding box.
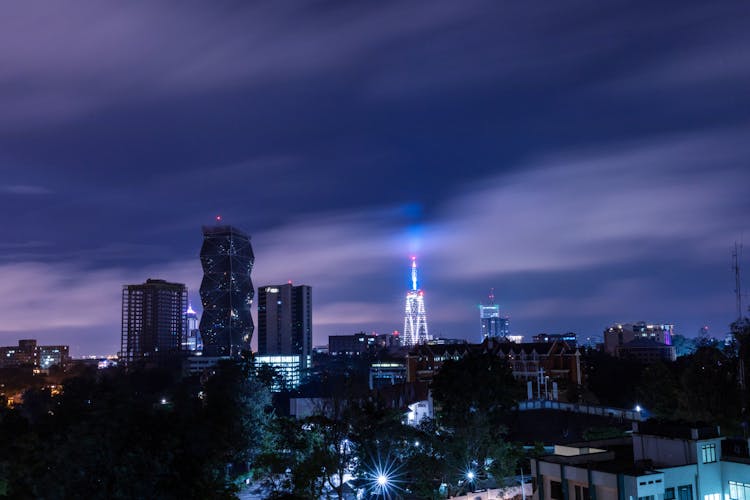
[0,355,523,499]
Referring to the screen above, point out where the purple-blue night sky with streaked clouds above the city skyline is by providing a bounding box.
[0,0,750,356]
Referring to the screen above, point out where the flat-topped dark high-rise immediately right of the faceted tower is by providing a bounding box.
[258,283,312,369]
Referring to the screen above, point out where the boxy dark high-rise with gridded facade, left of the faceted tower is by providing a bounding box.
[120,279,187,365]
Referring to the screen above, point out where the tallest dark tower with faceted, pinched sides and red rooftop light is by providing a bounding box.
[200,225,255,356]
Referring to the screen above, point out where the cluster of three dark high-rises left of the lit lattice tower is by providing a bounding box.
[119,225,313,388]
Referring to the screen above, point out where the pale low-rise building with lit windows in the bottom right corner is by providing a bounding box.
[531,421,750,500]
